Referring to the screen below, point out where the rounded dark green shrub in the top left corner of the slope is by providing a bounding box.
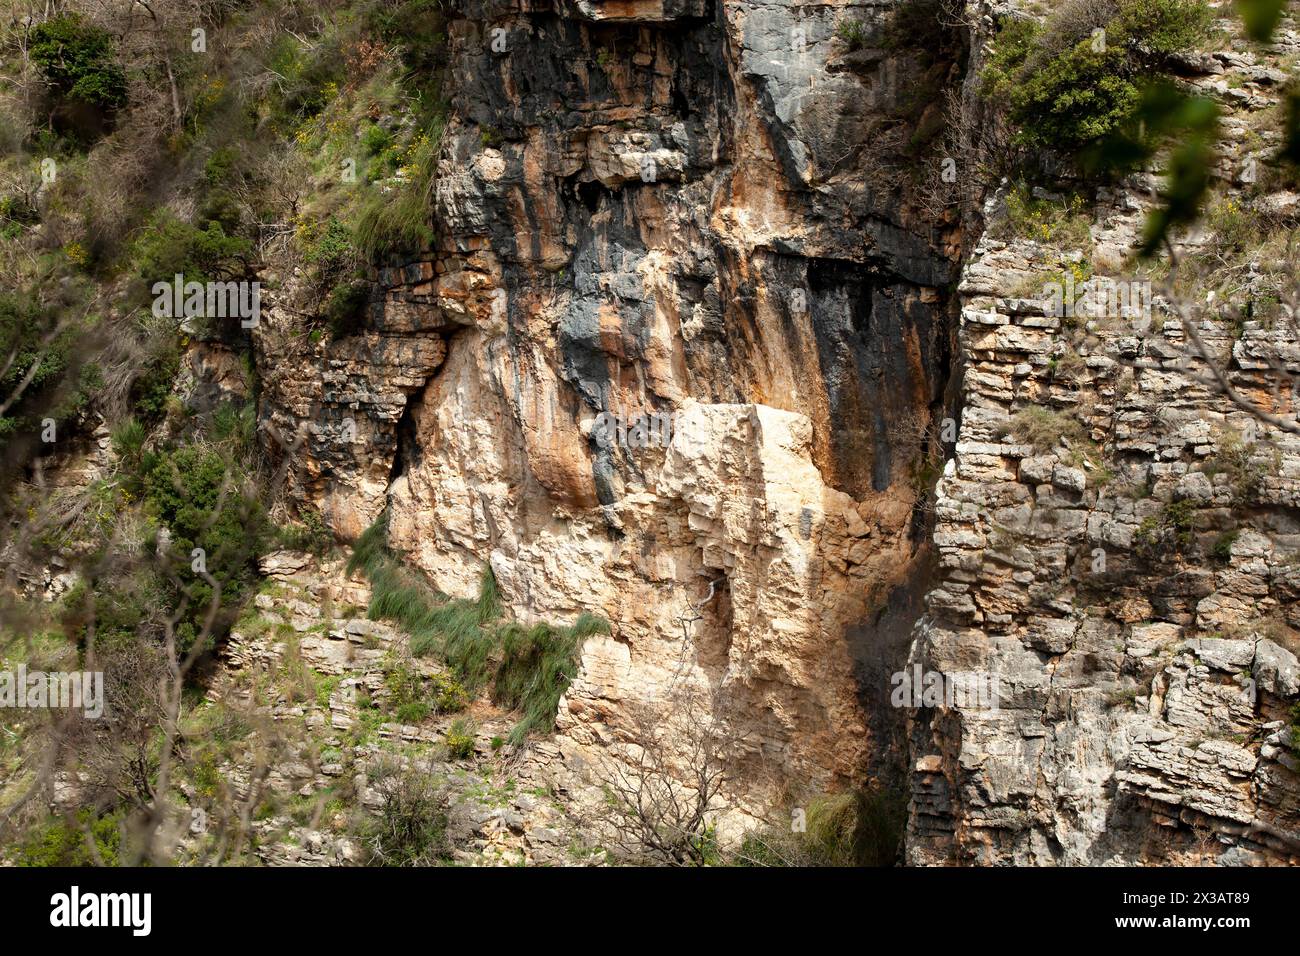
[27,16,126,111]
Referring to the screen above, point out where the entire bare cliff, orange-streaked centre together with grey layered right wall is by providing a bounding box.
[250,0,1300,864]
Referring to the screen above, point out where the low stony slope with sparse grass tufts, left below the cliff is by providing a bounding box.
[209,551,606,866]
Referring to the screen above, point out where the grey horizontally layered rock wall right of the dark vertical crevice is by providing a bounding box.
[907,3,1300,865]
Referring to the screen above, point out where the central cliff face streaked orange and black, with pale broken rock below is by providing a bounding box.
[263,3,961,812]
